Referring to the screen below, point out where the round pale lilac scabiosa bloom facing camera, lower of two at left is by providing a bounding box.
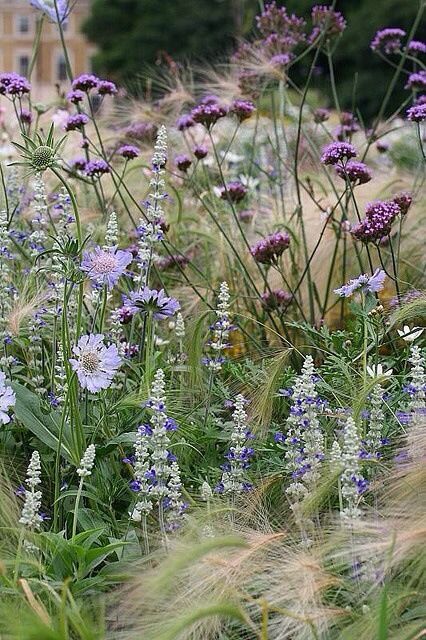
[70,333,121,393]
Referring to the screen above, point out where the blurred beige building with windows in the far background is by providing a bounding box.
[0,0,94,87]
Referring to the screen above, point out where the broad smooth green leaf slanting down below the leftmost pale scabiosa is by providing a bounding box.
[12,382,75,464]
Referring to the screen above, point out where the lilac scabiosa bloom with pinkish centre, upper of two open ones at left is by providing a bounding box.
[80,247,133,289]
